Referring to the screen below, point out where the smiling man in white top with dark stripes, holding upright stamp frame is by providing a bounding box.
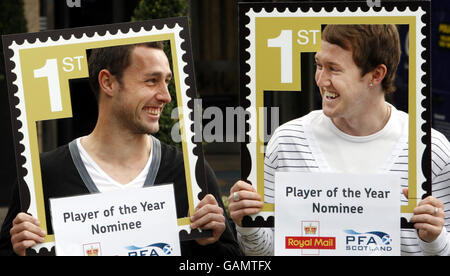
[229,25,450,255]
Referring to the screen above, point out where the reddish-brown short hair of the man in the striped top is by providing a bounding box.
[322,24,401,93]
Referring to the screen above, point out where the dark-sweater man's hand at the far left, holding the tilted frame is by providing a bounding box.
[9,213,46,256]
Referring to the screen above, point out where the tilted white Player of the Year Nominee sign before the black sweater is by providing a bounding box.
[50,185,181,256]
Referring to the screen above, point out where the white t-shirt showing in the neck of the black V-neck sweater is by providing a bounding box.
[77,138,153,193]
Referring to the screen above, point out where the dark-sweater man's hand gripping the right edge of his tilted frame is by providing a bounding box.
[191,194,226,245]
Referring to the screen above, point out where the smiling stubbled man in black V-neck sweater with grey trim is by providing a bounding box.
[0,42,241,256]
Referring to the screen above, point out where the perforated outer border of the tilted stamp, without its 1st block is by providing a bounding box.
[2,17,207,255]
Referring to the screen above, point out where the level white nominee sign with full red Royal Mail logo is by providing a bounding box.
[275,172,401,256]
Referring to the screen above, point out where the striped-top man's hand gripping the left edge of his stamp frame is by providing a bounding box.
[228,180,263,226]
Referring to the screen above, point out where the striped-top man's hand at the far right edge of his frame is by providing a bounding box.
[403,188,445,242]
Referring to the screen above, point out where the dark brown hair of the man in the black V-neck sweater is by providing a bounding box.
[88,41,165,101]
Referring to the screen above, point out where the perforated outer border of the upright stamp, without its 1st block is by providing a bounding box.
[239,1,431,228]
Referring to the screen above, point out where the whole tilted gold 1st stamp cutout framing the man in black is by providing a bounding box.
[3,17,207,253]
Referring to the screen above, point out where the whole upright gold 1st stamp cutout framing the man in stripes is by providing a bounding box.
[239,1,431,228]
